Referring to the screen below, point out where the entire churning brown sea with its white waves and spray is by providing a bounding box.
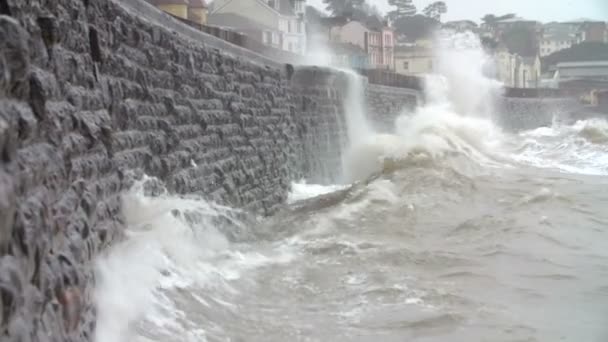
[97,35,608,342]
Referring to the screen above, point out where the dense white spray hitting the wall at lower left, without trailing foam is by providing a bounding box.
[95,177,229,342]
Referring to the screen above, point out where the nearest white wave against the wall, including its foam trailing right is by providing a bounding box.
[95,177,292,342]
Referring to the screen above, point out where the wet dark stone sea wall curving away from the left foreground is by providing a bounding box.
[0,0,420,341]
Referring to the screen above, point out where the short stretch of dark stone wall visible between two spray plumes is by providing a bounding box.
[366,84,422,132]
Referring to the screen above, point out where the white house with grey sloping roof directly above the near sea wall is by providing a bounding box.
[209,0,306,55]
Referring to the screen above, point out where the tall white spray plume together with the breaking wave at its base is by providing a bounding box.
[344,33,502,182]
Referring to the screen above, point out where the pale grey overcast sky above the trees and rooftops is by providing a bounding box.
[308,0,608,22]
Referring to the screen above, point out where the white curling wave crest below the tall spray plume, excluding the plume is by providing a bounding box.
[344,104,506,182]
